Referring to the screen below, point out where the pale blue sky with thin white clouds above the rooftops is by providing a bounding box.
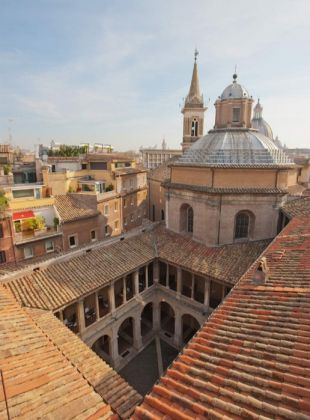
[0,0,310,150]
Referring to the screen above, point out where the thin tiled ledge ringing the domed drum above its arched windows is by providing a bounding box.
[162,181,287,194]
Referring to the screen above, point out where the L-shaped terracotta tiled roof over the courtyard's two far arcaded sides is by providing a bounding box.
[5,226,269,310]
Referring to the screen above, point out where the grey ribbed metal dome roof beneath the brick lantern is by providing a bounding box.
[176,128,292,167]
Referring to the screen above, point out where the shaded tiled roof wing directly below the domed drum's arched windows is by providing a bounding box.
[156,226,270,284]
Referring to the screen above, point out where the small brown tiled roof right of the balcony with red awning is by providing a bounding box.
[55,194,99,222]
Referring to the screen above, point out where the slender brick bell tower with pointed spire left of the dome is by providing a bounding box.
[182,49,207,151]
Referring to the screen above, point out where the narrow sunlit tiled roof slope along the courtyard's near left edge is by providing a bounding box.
[26,309,142,419]
